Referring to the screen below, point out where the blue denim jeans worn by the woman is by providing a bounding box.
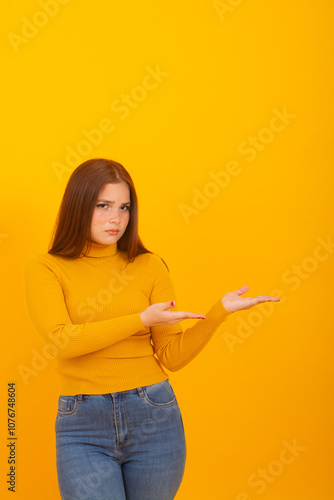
[55,380,186,500]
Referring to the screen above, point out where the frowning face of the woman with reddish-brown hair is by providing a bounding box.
[90,181,130,245]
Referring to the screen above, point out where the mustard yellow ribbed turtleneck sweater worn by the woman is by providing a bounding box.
[24,243,231,396]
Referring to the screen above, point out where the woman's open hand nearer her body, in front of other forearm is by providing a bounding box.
[140,300,205,328]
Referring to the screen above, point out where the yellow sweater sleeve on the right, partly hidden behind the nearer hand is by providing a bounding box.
[150,255,232,371]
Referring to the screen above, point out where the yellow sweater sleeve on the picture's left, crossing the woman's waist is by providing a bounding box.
[24,257,147,358]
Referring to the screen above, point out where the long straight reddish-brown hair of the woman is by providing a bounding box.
[48,158,153,264]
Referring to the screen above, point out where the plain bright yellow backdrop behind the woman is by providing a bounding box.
[0,0,334,500]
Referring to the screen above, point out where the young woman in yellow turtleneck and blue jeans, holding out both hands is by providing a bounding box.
[25,159,279,500]
